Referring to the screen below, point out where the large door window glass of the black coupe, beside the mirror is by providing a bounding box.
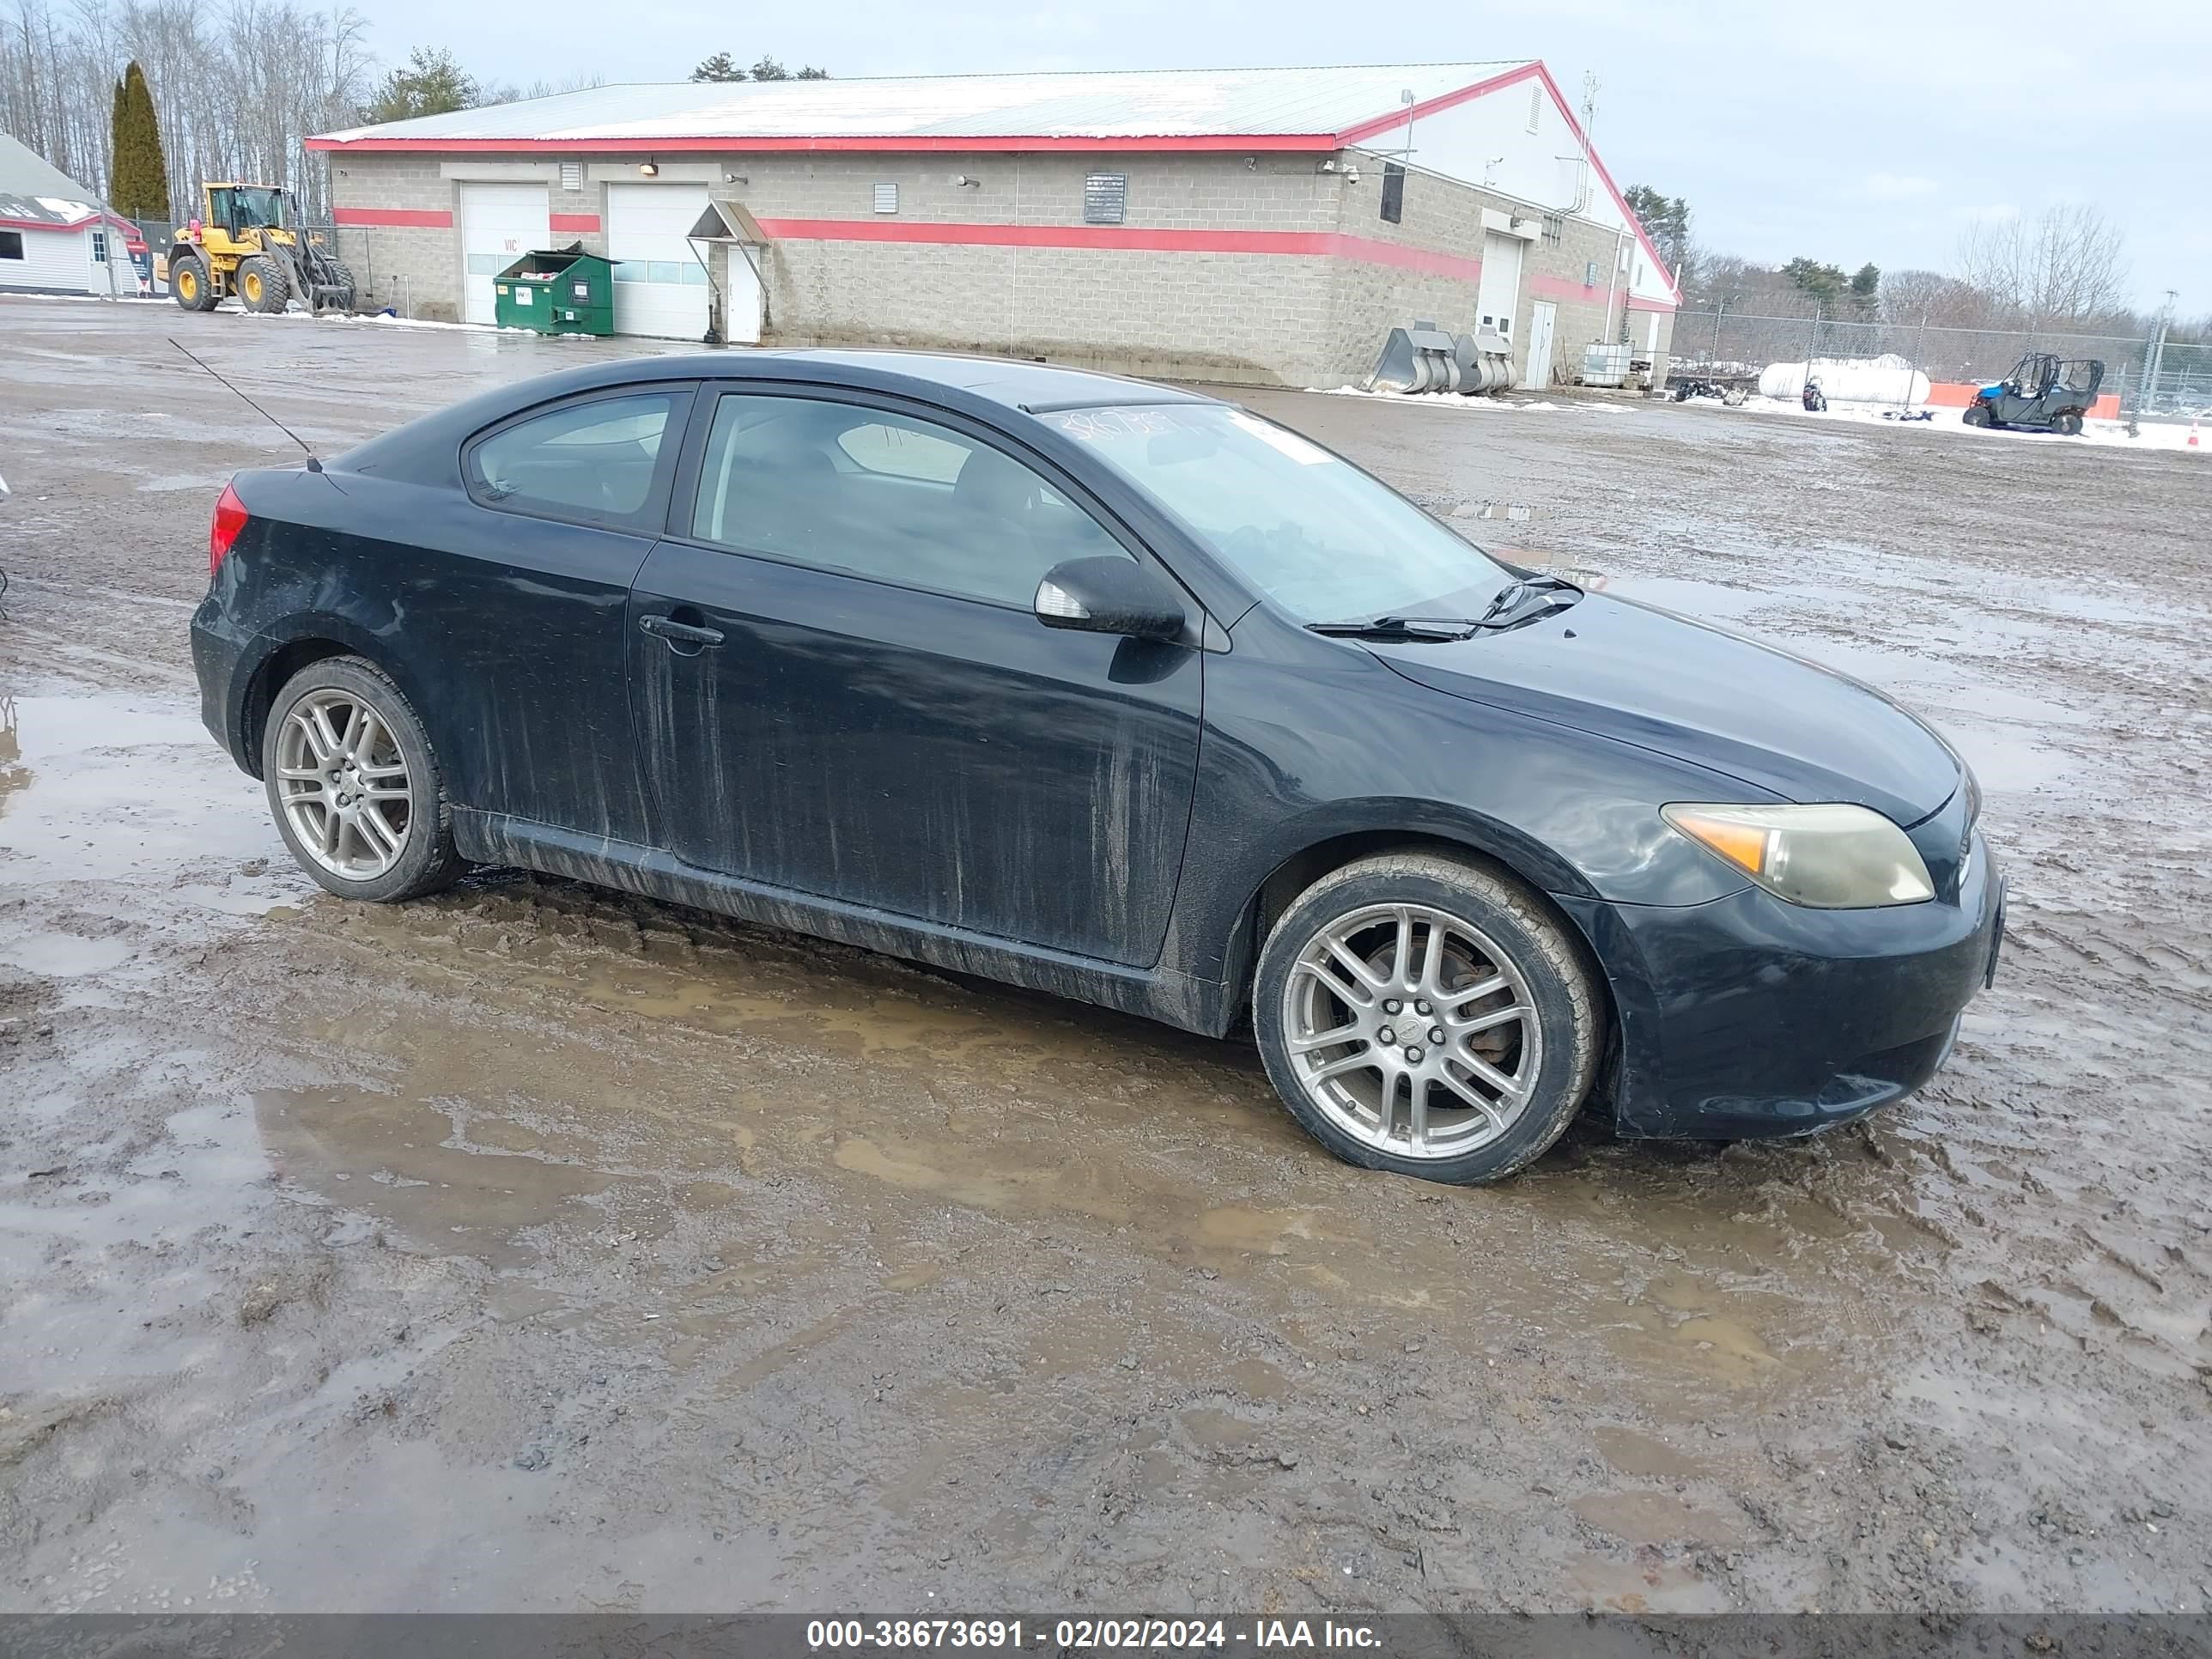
[692,394,1130,611]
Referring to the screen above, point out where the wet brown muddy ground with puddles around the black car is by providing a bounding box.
[0,299,2212,1613]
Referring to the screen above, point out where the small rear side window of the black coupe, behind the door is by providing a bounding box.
[462,392,677,525]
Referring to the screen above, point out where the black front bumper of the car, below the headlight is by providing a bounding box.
[1559,832,2004,1139]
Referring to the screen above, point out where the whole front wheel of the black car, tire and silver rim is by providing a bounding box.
[1252,852,1604,1186]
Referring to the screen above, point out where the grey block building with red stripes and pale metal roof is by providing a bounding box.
[310,60,1679,389]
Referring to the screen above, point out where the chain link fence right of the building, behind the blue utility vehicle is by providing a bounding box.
[1670,307,2212,420]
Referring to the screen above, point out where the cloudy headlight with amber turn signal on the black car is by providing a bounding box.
[1659,805,1936,909]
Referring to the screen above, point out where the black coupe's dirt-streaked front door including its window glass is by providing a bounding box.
[630,387,1203,964]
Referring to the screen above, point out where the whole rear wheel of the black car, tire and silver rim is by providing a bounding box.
[261,657,467,905]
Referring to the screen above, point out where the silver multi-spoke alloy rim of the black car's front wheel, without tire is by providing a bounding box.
[1283,905,1544,1159]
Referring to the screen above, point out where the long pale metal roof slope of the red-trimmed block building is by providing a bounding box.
[312,58,1533,149]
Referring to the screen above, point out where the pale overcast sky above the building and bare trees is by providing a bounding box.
[356,0,2212,316]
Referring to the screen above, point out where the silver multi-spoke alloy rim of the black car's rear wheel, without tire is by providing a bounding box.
[276,688,414,880]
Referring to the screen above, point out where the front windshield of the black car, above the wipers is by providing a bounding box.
[1037,404,1513,622]
